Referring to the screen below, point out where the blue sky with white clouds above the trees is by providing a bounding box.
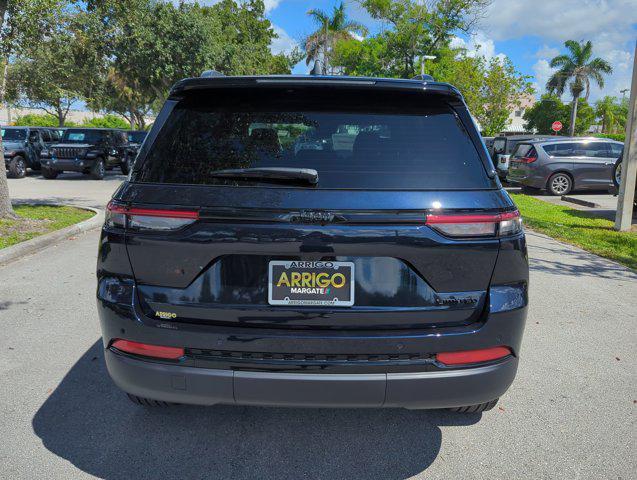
[256,0,637,101]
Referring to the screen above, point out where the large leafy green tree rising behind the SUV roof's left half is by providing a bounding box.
[82,0,299,129]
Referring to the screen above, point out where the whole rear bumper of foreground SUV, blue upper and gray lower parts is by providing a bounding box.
[98,286,527,409]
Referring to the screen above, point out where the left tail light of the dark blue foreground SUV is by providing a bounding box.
[105,201,199,231]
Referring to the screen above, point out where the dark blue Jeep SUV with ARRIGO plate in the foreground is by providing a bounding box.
[97,76,528,412]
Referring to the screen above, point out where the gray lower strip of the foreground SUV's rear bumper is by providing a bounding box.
[105,349,518,409]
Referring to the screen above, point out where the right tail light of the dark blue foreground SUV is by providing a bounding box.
[426,210,522,237]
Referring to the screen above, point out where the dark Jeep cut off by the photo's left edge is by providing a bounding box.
[2,127,50,178]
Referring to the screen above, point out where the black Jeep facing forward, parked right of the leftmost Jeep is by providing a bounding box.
[41,128,132,180]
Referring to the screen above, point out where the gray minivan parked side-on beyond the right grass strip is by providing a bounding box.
[507,137,624,195]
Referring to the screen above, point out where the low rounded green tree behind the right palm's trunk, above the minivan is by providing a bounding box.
[523,94,595,135]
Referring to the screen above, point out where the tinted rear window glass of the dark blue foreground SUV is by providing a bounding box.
[134,91,493,189]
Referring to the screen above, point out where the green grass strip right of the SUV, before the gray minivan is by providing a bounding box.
[511,194,637,269]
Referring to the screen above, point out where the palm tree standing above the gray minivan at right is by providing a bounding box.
[546,40,613,136]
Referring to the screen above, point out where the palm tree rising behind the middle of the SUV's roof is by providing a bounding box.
[305,2,367,73]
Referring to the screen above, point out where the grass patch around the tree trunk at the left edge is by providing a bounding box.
[0,205,95,248]
